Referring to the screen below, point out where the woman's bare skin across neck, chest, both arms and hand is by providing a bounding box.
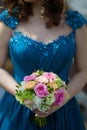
[0,0,87,117]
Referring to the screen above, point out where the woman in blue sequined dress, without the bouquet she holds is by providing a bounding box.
[0,0,87,130]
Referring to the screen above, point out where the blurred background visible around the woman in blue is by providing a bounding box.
[0,0,87,130]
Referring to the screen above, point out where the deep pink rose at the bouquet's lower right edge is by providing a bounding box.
[54,88,65,105]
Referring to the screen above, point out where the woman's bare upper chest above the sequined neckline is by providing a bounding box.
[16,20,72,44]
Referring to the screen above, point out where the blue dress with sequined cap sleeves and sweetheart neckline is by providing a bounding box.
[0,10,87,130]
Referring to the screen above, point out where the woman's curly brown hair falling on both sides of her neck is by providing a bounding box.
[3,0,64,27]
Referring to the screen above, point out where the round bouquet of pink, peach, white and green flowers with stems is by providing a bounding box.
[16,70,69,127]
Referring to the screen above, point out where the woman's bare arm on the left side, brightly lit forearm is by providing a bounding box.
[0,22,17,95]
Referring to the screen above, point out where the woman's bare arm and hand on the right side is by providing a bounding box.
[36,25,87,117]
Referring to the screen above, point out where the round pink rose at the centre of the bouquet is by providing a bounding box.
[34,83,49,98]
